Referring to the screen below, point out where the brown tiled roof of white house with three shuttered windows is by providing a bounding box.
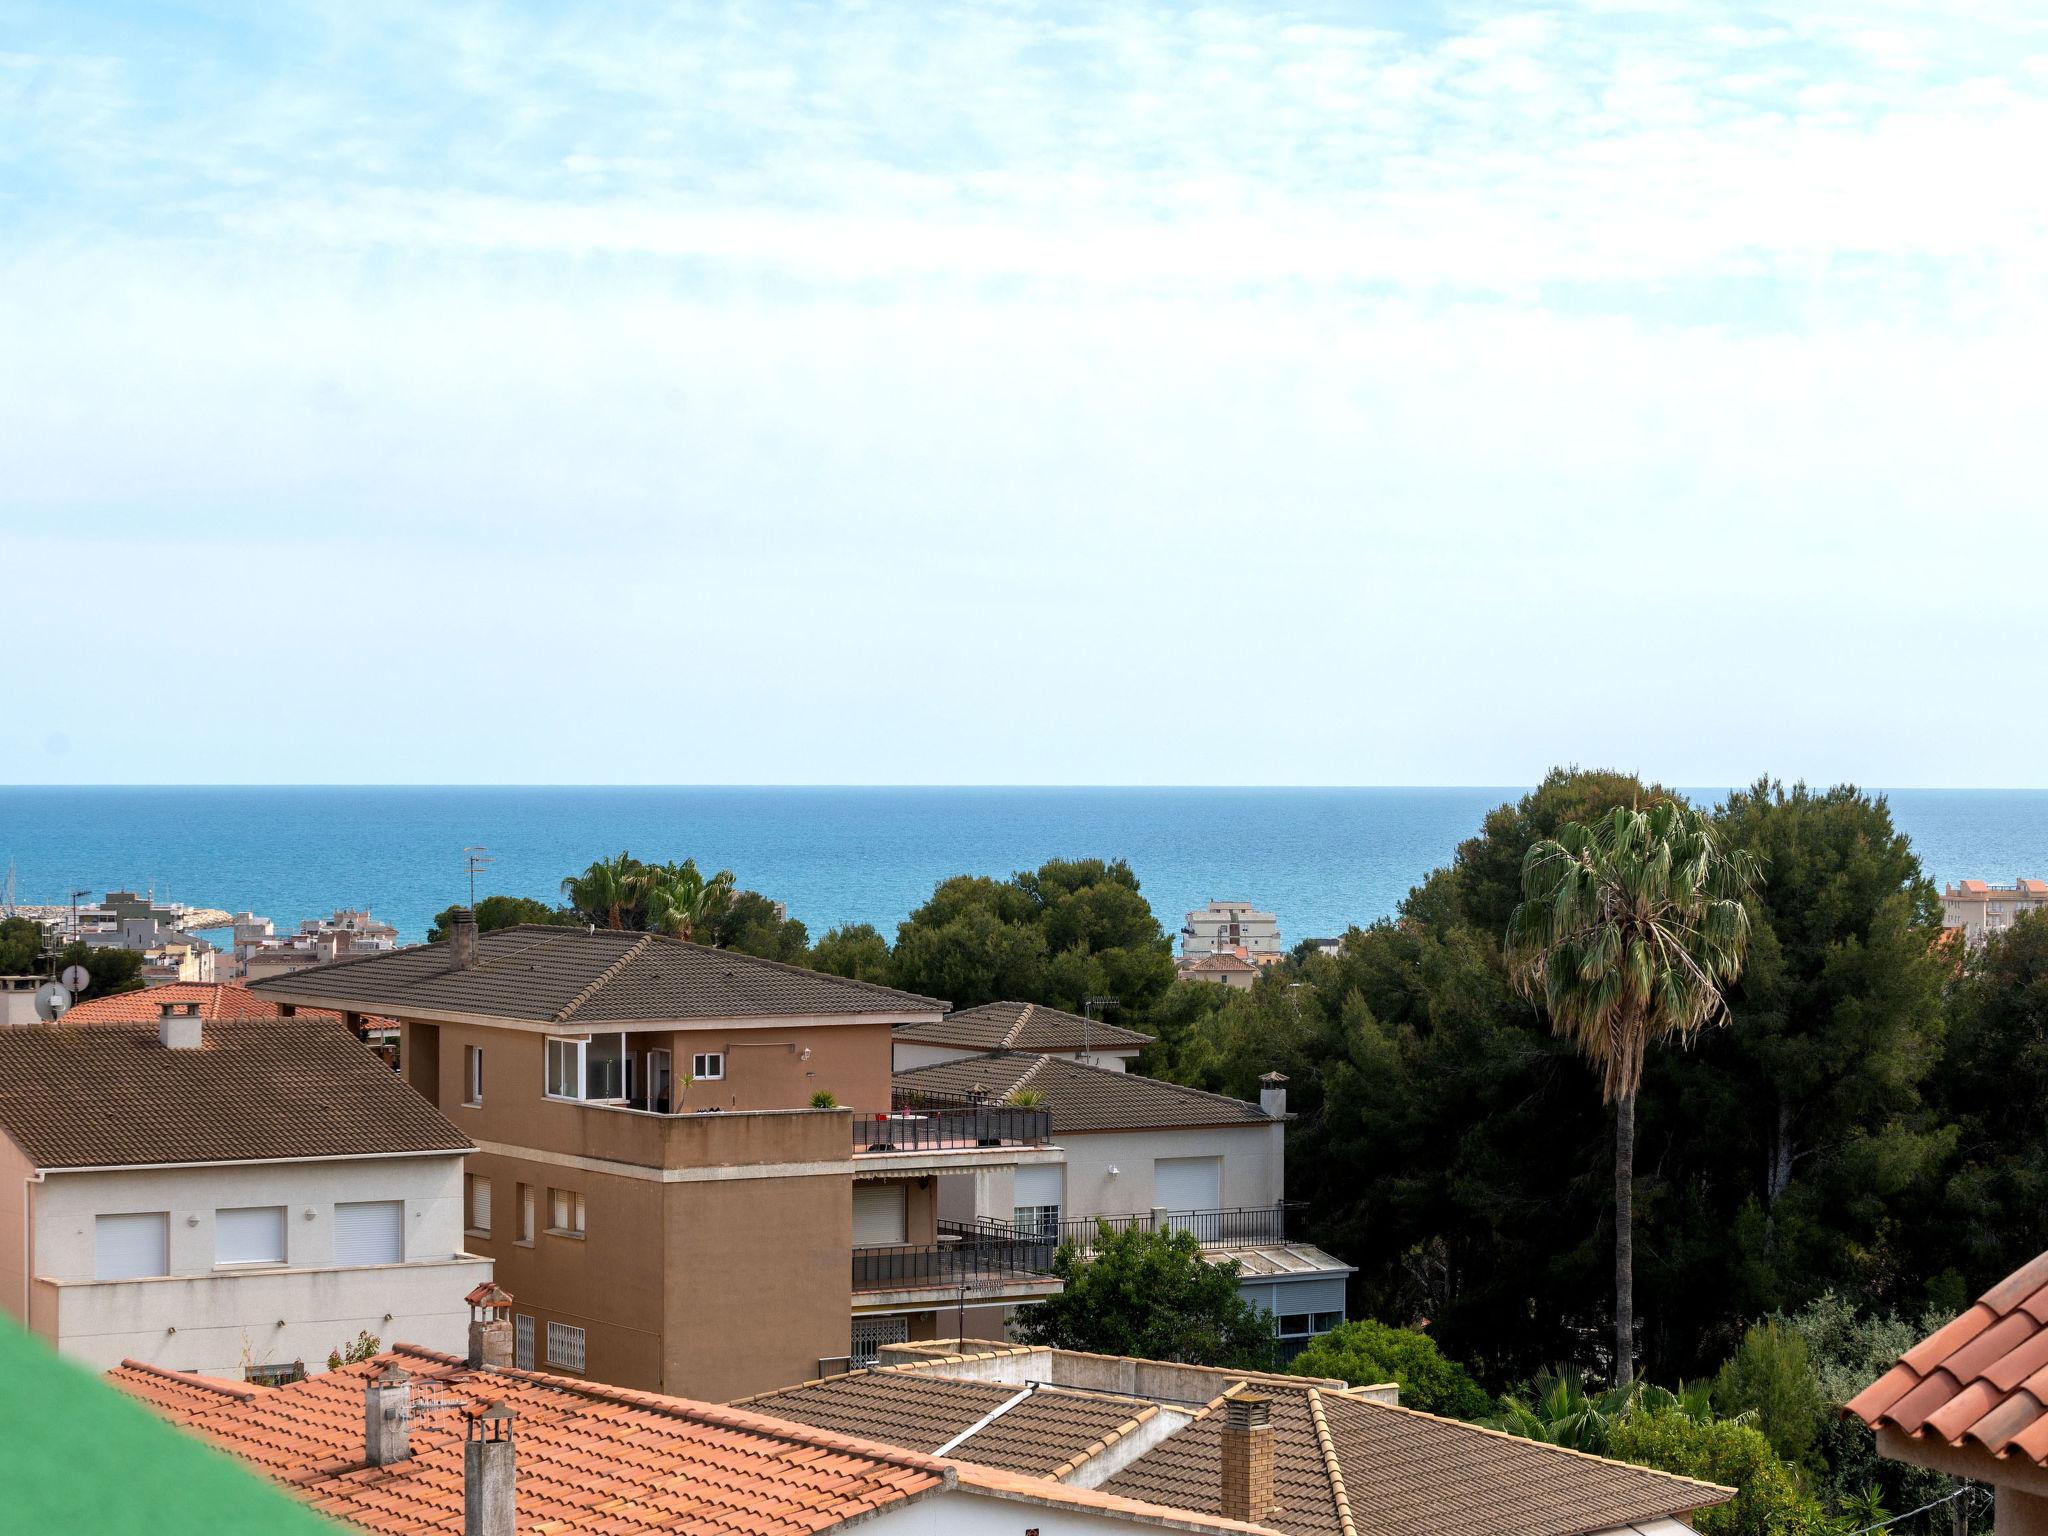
[0,1018,471,1167]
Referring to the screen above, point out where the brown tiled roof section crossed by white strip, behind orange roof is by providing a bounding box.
[741,1370,1159,1477]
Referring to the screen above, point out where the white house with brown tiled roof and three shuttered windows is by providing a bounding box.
[0,1001,492,1380]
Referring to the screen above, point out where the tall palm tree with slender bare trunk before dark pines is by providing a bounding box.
[1507,801,1757,1382]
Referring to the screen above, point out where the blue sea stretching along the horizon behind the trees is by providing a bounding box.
[0,786,2048,942]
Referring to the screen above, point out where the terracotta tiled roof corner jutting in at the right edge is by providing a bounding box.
[1843,1253,2048,1466]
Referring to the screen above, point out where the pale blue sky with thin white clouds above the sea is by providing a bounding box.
[0,0,2048,786]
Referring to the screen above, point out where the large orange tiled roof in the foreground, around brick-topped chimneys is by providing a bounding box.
[109,1346,1268,1536]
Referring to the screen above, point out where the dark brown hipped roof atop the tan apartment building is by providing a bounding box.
[252,926,946,1026]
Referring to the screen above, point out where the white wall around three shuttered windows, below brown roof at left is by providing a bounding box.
[35,1155,492,1378]
